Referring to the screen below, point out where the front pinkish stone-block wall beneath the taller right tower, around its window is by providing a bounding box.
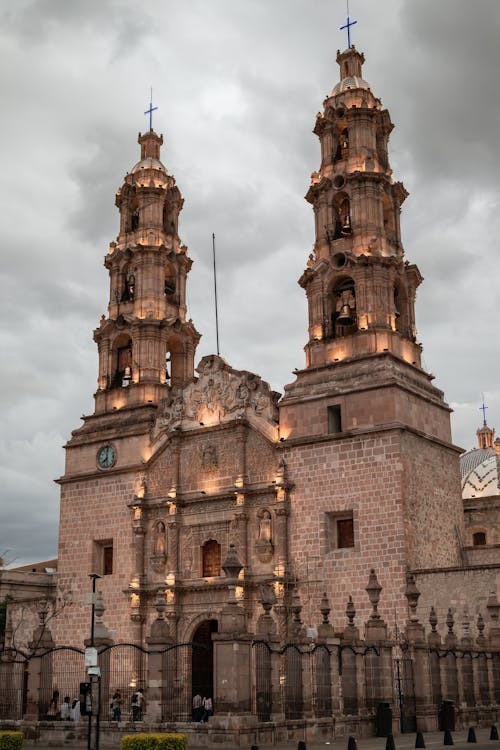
[285,430,406,629]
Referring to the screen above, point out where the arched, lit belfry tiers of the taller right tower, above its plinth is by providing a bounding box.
[300,47,422,374]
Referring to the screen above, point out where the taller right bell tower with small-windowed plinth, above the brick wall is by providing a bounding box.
[281,46,451,450]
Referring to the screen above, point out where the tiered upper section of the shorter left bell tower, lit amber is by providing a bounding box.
[94,130,200,414]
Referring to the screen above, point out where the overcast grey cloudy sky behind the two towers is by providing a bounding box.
[0,0,500,565]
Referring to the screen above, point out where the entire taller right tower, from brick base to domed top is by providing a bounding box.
[279,46,463,584]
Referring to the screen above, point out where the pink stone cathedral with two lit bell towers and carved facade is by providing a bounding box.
[2,46,500,739]
